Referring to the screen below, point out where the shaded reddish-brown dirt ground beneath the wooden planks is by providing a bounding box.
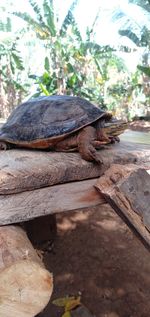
[38,204,150,317]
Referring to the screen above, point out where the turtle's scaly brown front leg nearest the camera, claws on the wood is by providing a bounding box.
[77,126,103,164]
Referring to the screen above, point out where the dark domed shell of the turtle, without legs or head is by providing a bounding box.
[0,95,107,144]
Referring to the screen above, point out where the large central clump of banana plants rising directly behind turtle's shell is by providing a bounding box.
[14,0,121,105]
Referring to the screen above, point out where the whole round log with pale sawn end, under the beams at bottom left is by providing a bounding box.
[0,226,53,317]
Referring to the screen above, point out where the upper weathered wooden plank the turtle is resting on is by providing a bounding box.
[0,141,150,195]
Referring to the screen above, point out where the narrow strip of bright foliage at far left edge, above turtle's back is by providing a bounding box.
[0,17,28,117]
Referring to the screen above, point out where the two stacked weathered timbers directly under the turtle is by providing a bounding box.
[0,142,150,225]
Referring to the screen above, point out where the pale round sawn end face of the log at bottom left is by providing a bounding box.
[0,260,53,317]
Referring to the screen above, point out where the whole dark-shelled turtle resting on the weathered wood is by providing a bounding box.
[0,95,125,163]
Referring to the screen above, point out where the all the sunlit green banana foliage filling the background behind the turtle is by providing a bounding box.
[0,0,150,118]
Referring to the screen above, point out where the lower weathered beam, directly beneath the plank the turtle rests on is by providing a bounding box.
[0,179,105,225]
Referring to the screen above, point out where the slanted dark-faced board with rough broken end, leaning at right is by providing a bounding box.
[95,164,150,246]
